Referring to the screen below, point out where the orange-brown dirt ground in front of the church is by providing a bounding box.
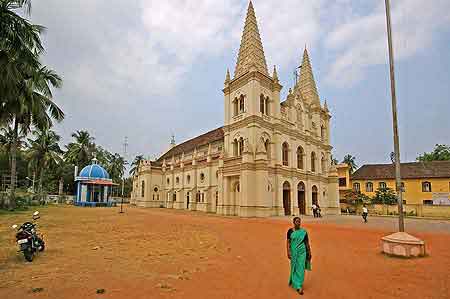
[0,206,450,299]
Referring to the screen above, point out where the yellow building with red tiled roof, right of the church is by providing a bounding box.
[352,161,450,205]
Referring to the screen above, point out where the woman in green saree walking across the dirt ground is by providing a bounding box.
[287,217,311,295]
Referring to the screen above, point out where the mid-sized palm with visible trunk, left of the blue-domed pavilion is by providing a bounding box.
[28,130,63,199]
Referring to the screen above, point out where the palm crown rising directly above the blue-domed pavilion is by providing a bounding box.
[65,130,95,167]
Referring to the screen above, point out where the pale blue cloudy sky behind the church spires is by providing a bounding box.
[31,0,450,165]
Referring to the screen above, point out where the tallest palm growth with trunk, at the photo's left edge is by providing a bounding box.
[0,0,64,208]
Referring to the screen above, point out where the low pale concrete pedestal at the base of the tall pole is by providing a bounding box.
[381,232,425,257]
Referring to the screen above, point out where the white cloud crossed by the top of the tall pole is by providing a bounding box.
[325,0,450,86]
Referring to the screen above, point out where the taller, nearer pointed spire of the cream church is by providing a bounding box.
[234,1,269,78]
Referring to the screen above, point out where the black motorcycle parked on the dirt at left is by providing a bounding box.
[12,211,45,262]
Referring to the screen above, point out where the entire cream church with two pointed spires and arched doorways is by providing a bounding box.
[131,2,340,217]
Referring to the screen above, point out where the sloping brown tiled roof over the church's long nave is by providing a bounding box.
[157,127,224,162]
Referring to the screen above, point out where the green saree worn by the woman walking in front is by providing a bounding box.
[289,228,311,290]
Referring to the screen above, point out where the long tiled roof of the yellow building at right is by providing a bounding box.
[352,161,450,180]
